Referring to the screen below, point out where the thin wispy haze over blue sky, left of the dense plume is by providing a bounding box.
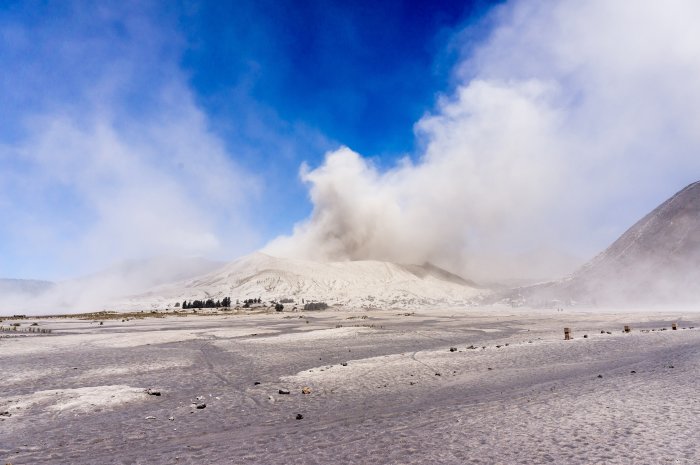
[0,2,260,278]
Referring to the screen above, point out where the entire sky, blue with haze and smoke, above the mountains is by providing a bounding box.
[0,0,700,279]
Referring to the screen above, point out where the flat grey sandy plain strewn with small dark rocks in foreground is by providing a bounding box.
[0,308,700,465]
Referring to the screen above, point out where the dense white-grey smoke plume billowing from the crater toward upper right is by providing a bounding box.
[267,0,700,279]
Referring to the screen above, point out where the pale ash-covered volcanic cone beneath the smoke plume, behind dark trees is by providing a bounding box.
[120,252,480,308]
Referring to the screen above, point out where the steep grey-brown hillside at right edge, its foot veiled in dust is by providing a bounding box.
[508,182,700,306]
